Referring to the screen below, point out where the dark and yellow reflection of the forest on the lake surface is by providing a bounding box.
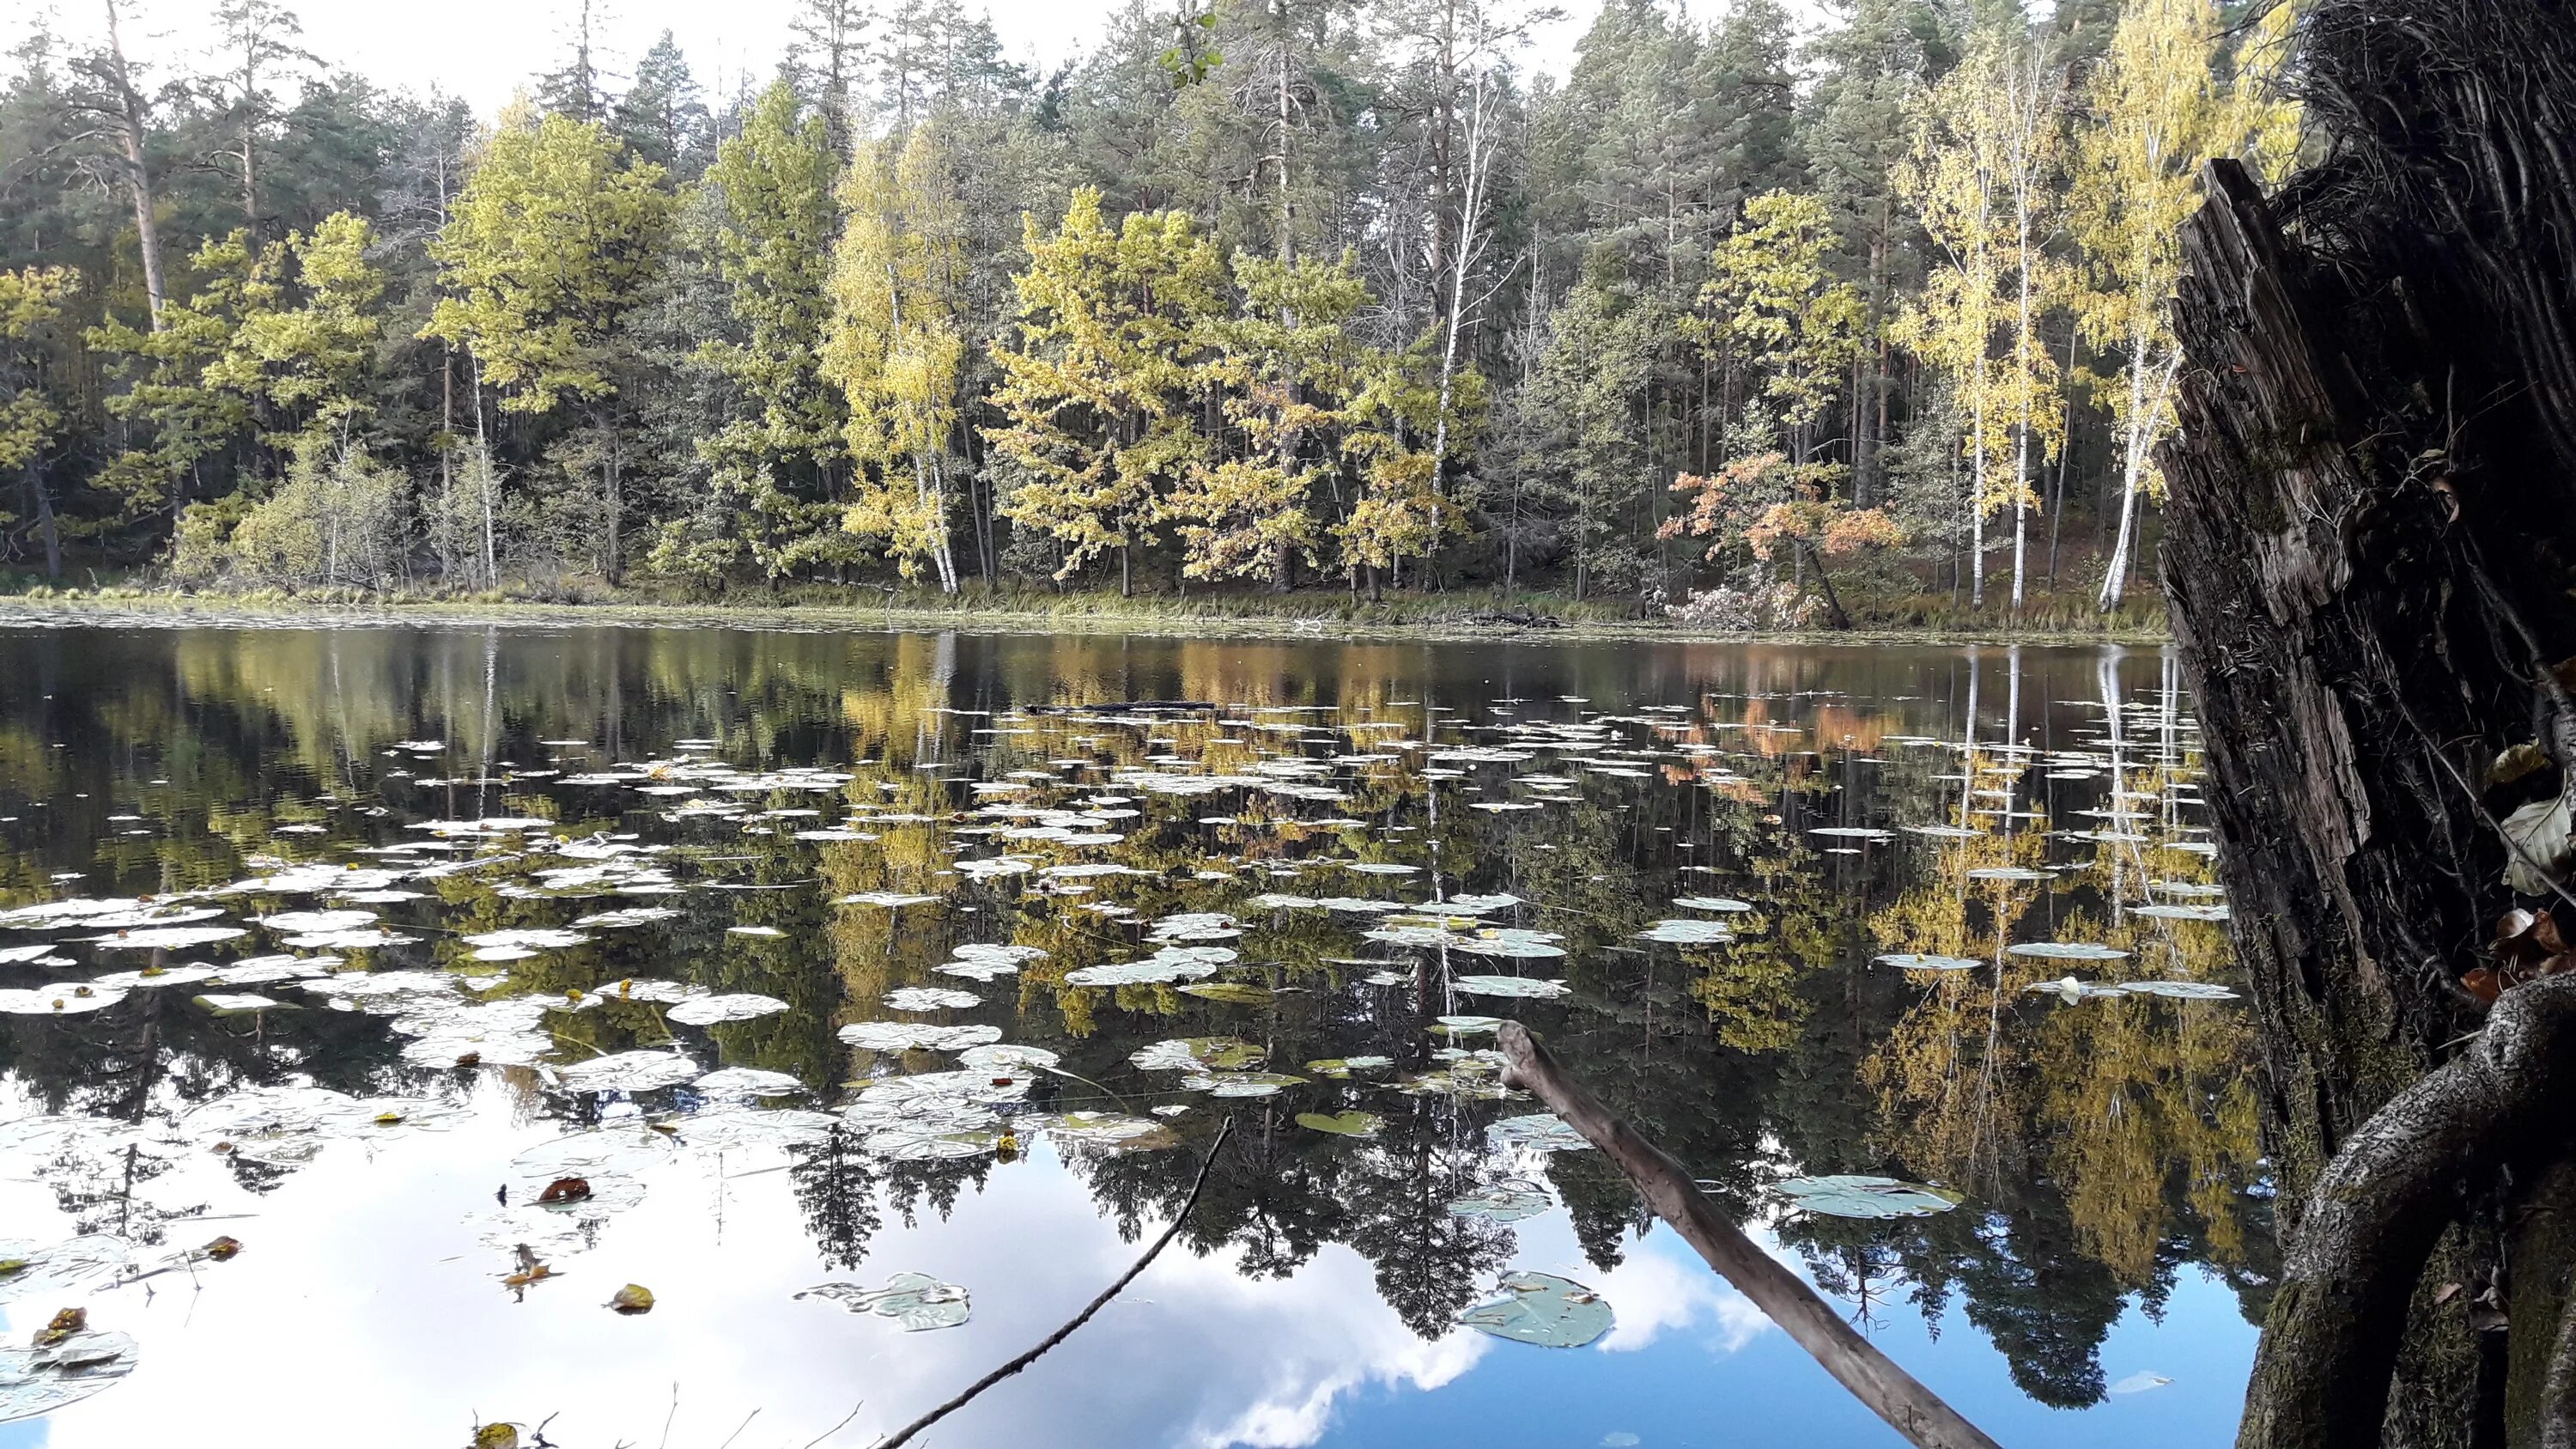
[0,629,2272,1405]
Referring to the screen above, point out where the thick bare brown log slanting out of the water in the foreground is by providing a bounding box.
[1499,1021,1999,1449]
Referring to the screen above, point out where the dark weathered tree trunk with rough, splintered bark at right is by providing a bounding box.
[2161,0,2576,1449]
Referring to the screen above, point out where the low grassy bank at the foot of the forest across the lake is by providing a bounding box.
[0,577,2164,644]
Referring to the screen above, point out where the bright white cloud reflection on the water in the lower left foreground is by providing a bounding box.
[0,1091,1759,1449]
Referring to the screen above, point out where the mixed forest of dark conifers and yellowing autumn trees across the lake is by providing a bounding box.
[0,0,2300,613]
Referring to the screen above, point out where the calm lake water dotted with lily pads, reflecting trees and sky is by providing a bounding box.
[0,629,2269,1449]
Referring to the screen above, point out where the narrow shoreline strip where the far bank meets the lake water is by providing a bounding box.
[0,593,2172,647]
